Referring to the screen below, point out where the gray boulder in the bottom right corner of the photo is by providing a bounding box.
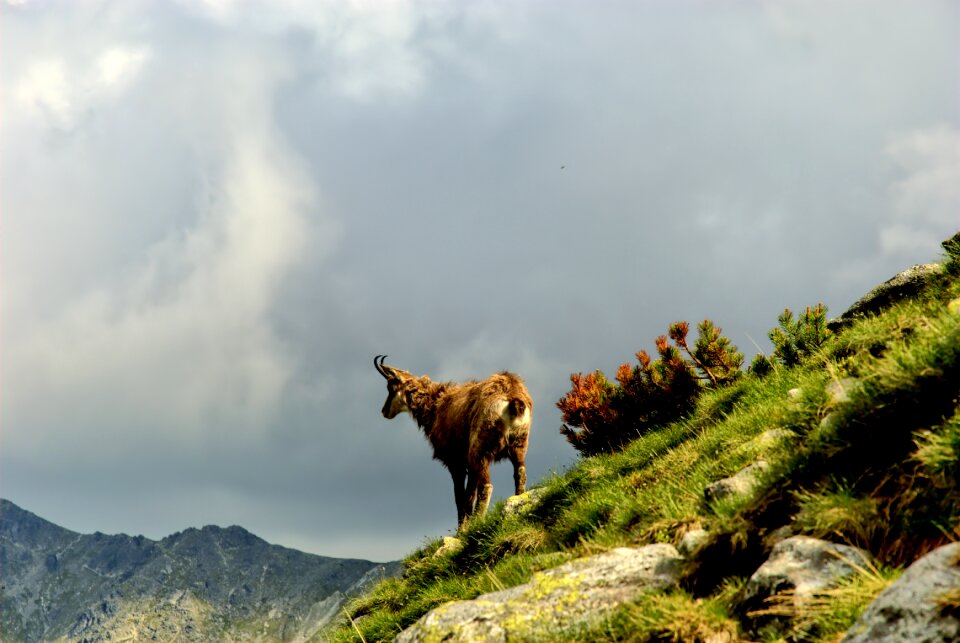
[843,543,960,643]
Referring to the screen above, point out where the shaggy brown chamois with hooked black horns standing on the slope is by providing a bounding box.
[373,355,533,529]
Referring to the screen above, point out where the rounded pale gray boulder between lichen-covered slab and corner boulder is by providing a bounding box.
[742,536,870,624]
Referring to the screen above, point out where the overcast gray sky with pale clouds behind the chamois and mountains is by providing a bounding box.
[0,0,960,560]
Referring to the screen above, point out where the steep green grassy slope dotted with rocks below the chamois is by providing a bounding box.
[332,249,960,642]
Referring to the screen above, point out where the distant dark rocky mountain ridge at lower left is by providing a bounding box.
[0,499,399,641]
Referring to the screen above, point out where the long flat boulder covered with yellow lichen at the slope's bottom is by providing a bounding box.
[394,544,682,643]
